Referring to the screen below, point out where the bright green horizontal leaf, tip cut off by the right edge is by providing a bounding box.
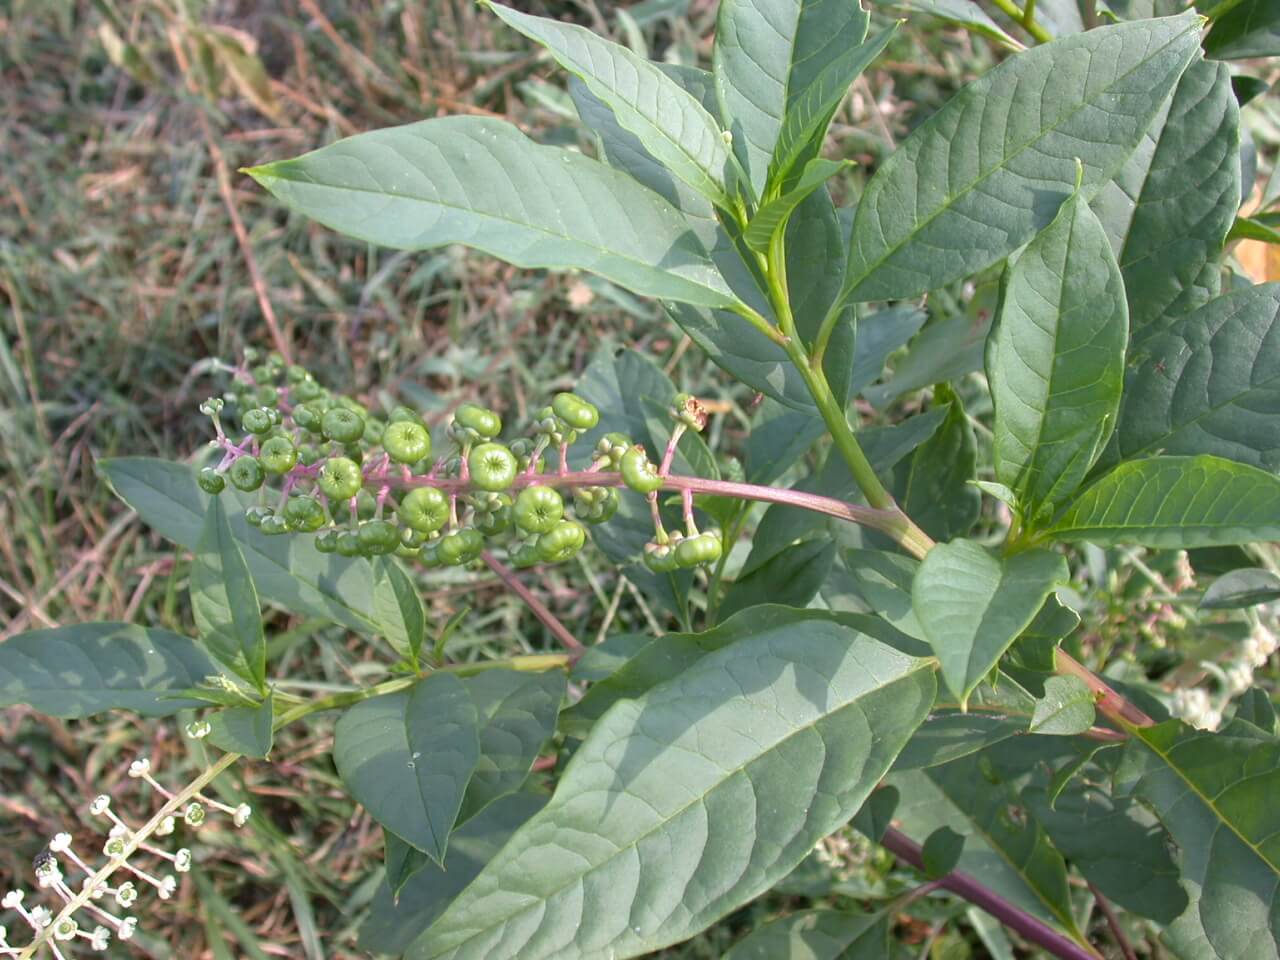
[1046,456,1280,549]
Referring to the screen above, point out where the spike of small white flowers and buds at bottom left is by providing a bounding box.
[0,758,252,960]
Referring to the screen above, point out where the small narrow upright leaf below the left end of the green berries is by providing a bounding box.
[191,497,266,692]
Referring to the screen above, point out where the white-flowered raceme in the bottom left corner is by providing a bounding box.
[0,742,252,960]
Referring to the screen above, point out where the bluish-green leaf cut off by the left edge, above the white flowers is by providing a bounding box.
[0,623,220,719]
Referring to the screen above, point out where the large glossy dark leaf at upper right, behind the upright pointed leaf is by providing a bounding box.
[1093,60,1240,339]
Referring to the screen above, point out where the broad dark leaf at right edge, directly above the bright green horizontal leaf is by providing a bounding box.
[1106,283,1280,472]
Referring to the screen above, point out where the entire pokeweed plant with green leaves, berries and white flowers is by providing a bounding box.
[0,0,1280,960]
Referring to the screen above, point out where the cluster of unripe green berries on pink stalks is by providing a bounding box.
[200,355,722,571]
